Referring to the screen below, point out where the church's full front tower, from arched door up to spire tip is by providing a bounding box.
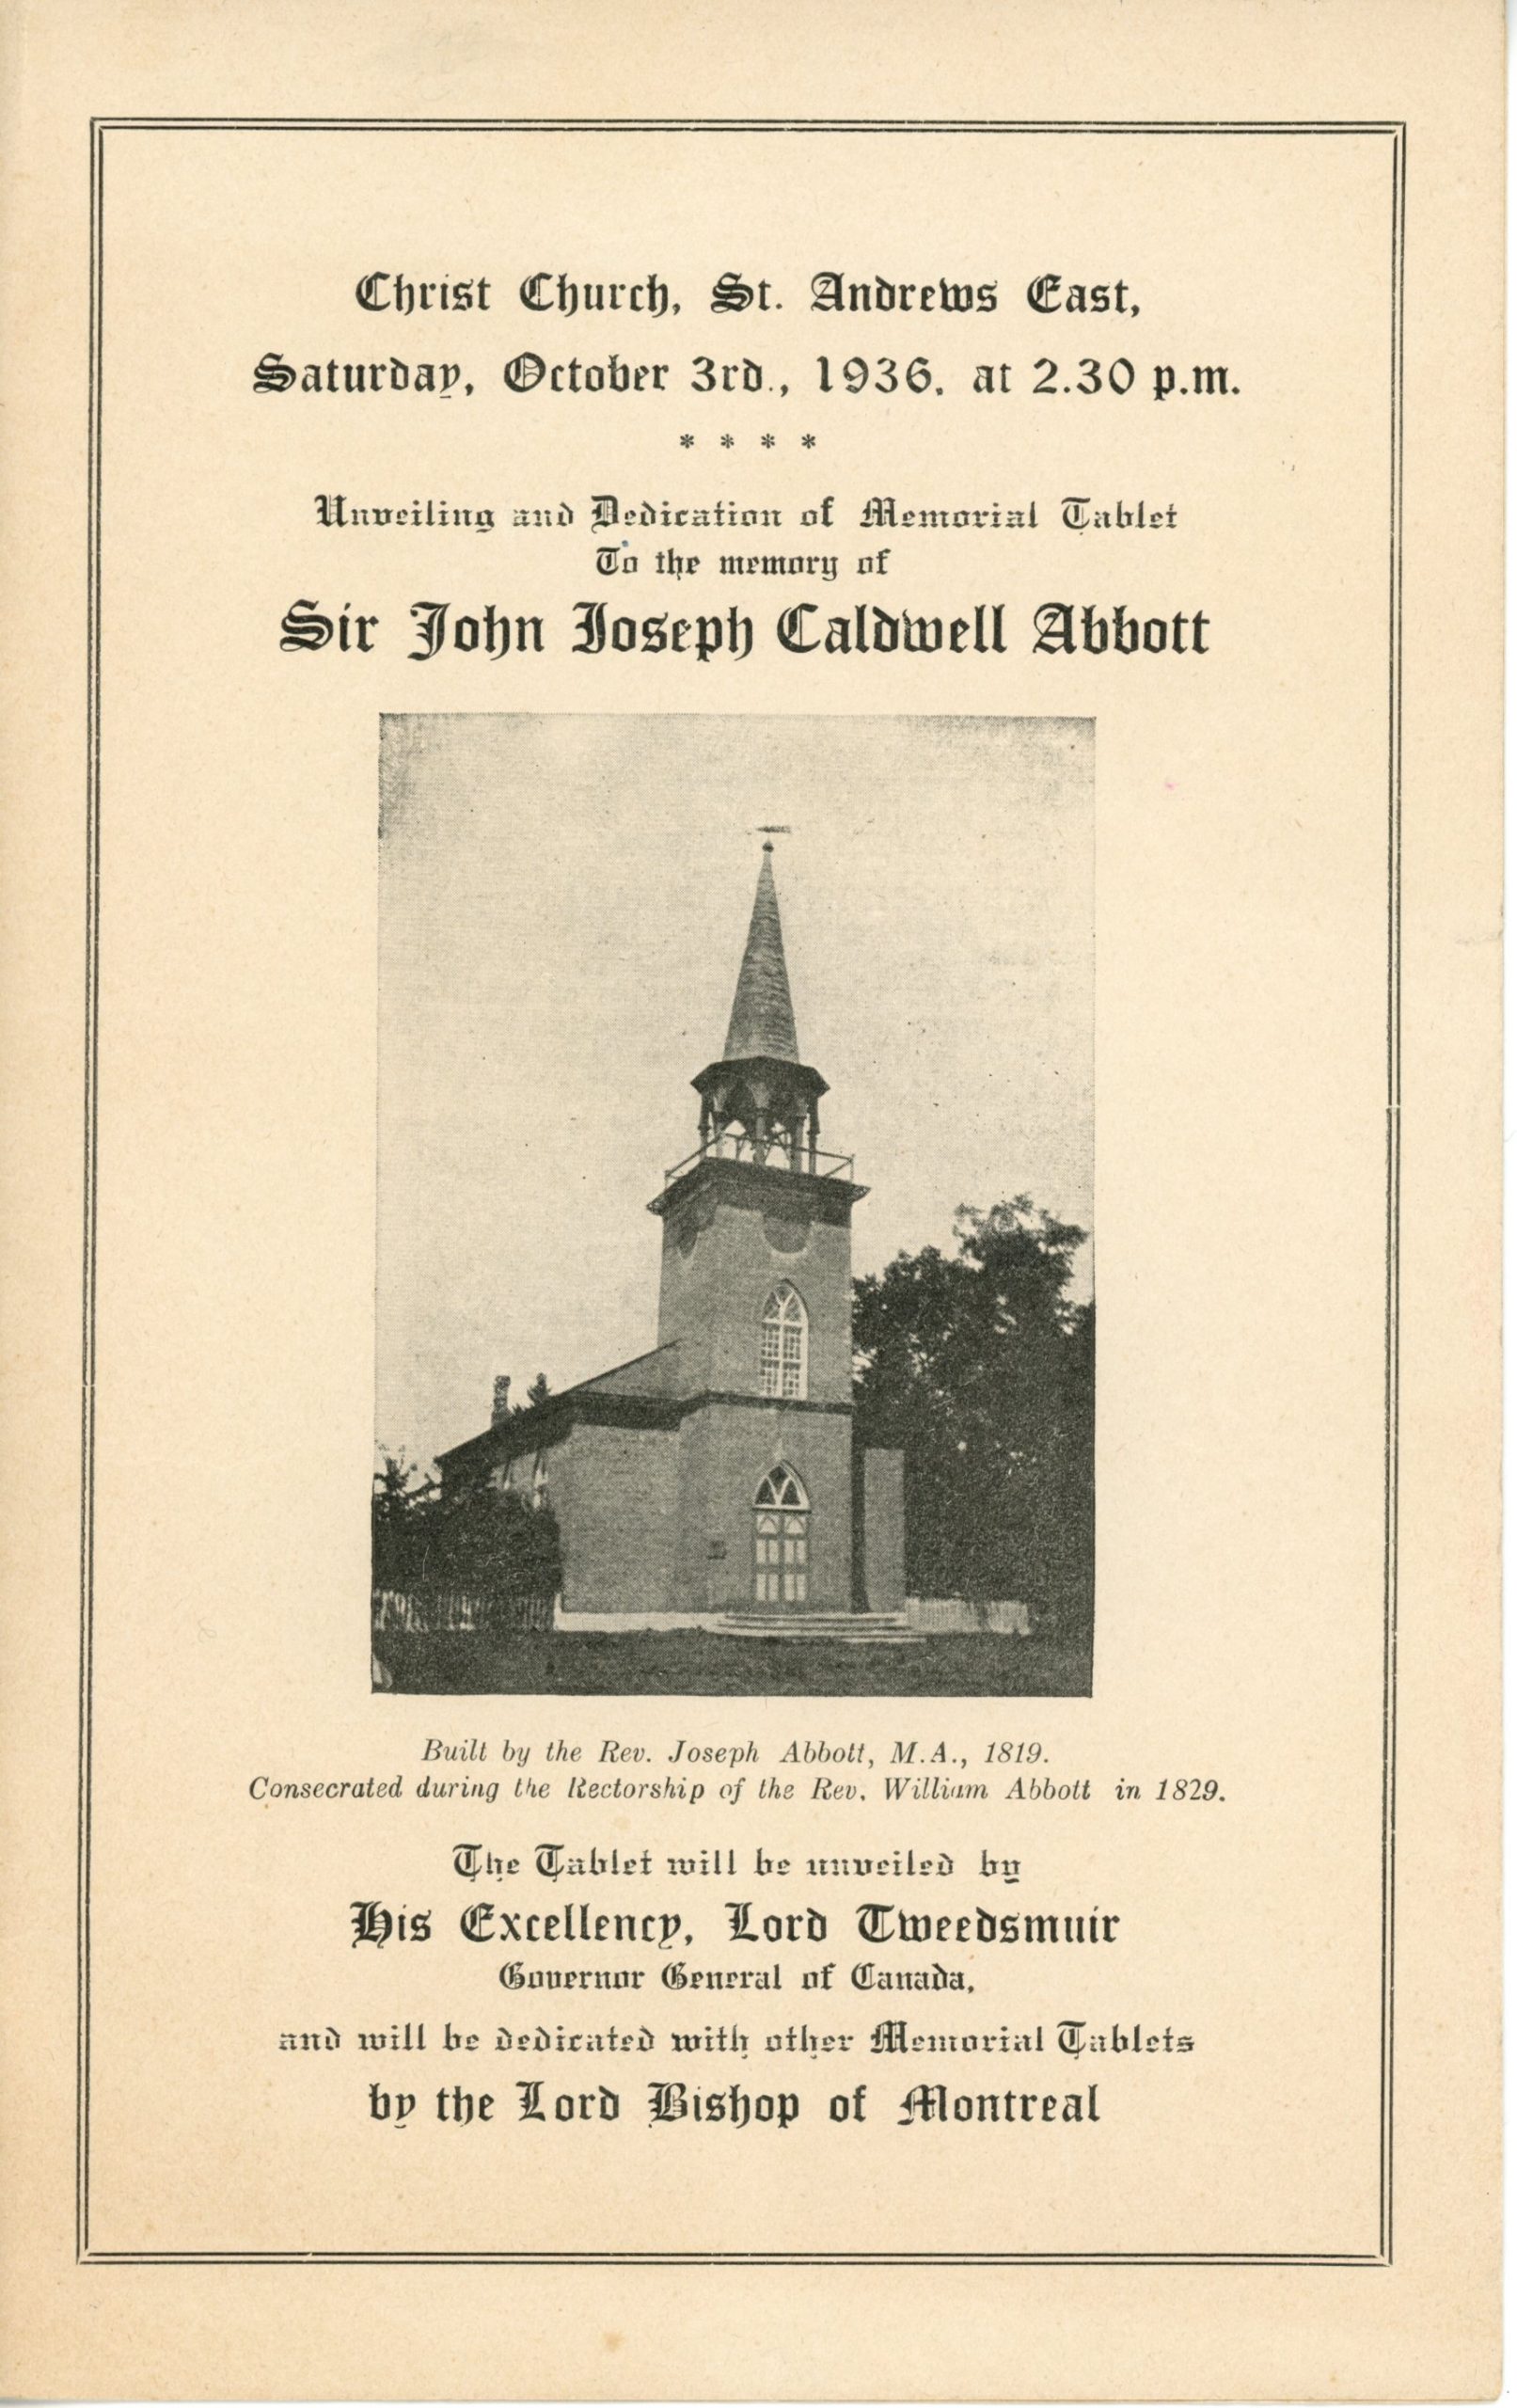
[650,843,867,1611]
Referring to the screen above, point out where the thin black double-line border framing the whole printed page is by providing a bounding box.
[74,118,1406,2266]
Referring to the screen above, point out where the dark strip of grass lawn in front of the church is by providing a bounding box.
[373,1630,1091,1698]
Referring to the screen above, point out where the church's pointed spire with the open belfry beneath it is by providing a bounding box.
[691,843,826,1173]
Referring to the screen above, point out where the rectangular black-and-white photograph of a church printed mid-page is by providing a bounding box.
[371,713,1096,1698]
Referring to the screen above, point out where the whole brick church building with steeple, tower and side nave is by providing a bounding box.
[438,843,906,1638]
